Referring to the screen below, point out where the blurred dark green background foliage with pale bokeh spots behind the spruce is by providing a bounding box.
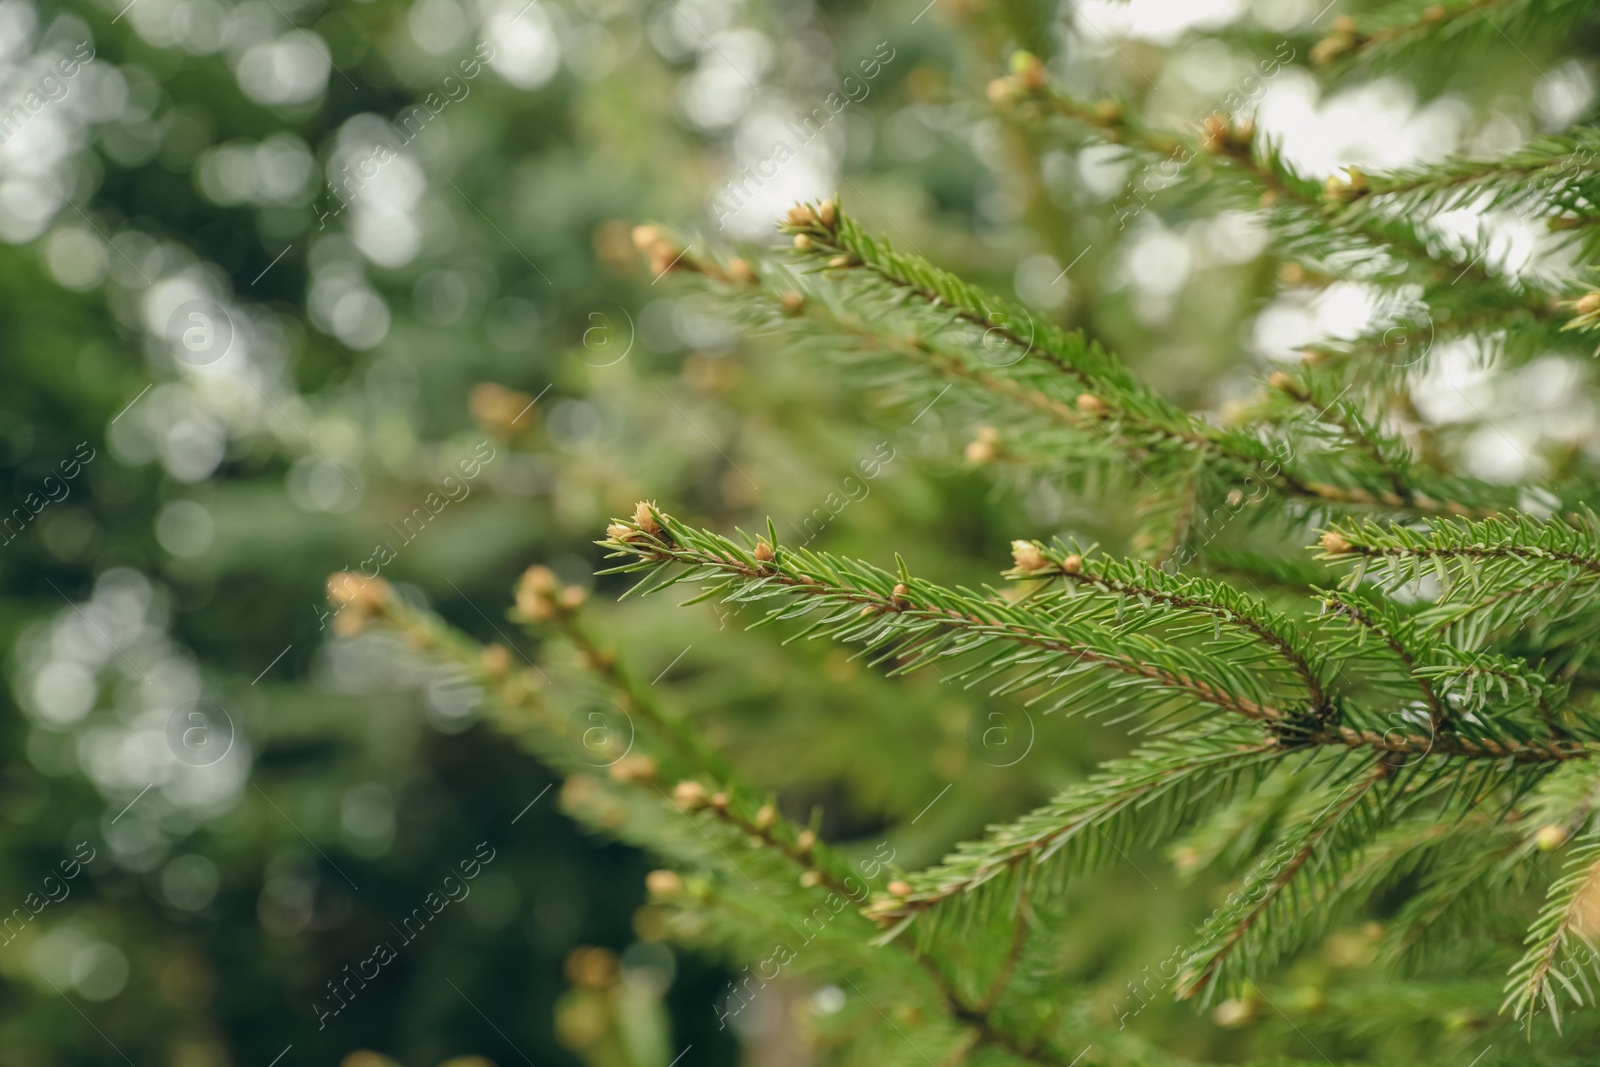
[0,0,1595,1067]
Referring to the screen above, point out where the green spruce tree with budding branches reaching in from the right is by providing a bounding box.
[330,0,1600,1067]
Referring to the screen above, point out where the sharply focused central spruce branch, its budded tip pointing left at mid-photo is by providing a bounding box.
[598,509,1595,763]
